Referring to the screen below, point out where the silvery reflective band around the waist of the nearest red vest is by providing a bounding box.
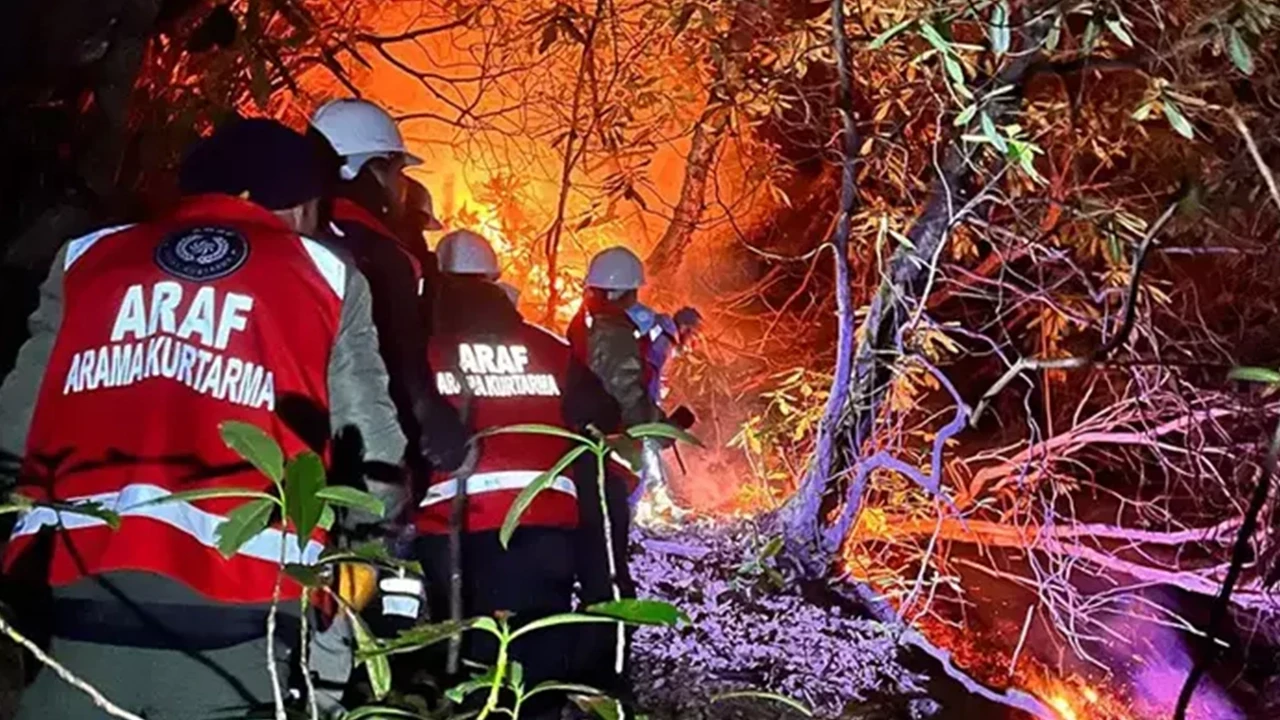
[13,484,324,565]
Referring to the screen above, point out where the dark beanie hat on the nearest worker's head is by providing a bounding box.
[178,119,330,210]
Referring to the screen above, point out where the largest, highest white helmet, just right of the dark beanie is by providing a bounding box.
[311,99,422,181]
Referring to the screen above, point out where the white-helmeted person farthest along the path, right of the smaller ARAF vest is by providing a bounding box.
[568,246,694,521]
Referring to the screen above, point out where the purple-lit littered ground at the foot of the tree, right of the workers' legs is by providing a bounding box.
[631,524,937,719]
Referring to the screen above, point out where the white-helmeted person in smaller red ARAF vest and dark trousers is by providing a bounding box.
[416,231,618,717]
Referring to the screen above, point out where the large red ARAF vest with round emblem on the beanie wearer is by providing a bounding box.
[5,195,347,603]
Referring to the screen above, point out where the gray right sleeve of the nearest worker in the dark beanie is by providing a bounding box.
[329,264,408,525]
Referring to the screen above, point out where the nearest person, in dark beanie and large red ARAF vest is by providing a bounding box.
[0,120,404,720]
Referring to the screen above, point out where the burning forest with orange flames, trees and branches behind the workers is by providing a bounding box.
[0,0,1280,720]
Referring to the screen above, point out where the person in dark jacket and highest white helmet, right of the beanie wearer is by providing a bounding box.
[311,100,466,482]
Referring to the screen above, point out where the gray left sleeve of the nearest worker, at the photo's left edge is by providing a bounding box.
[0,246,67,487]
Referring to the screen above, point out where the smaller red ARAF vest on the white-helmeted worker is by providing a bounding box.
[416,323,577,534]
